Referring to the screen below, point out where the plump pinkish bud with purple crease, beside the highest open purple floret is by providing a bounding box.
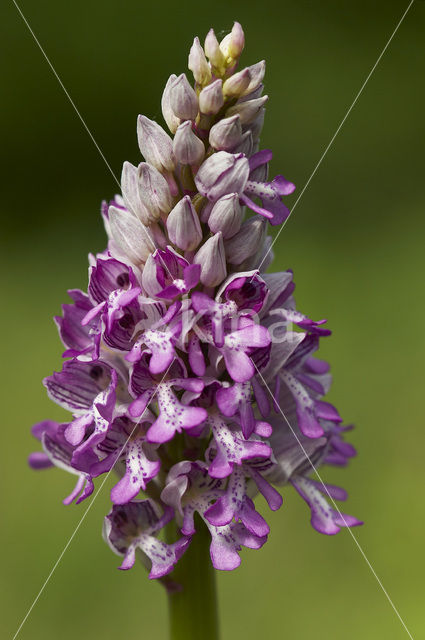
[195,151,249,201]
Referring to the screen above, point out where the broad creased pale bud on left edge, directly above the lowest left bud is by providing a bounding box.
[121,162,171,225]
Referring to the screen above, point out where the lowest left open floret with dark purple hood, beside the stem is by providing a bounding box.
[103,500,189,579]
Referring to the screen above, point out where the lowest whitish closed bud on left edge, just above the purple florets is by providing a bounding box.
[108,206,155,265]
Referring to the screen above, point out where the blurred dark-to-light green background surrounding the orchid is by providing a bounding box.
[0,0,425,640]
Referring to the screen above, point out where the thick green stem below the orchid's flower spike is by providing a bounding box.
[167,518,219,640]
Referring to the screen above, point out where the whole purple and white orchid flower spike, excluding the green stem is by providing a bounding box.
[30,23,359,578]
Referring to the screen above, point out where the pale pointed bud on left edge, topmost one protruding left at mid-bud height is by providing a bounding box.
[137,116,174,171]
